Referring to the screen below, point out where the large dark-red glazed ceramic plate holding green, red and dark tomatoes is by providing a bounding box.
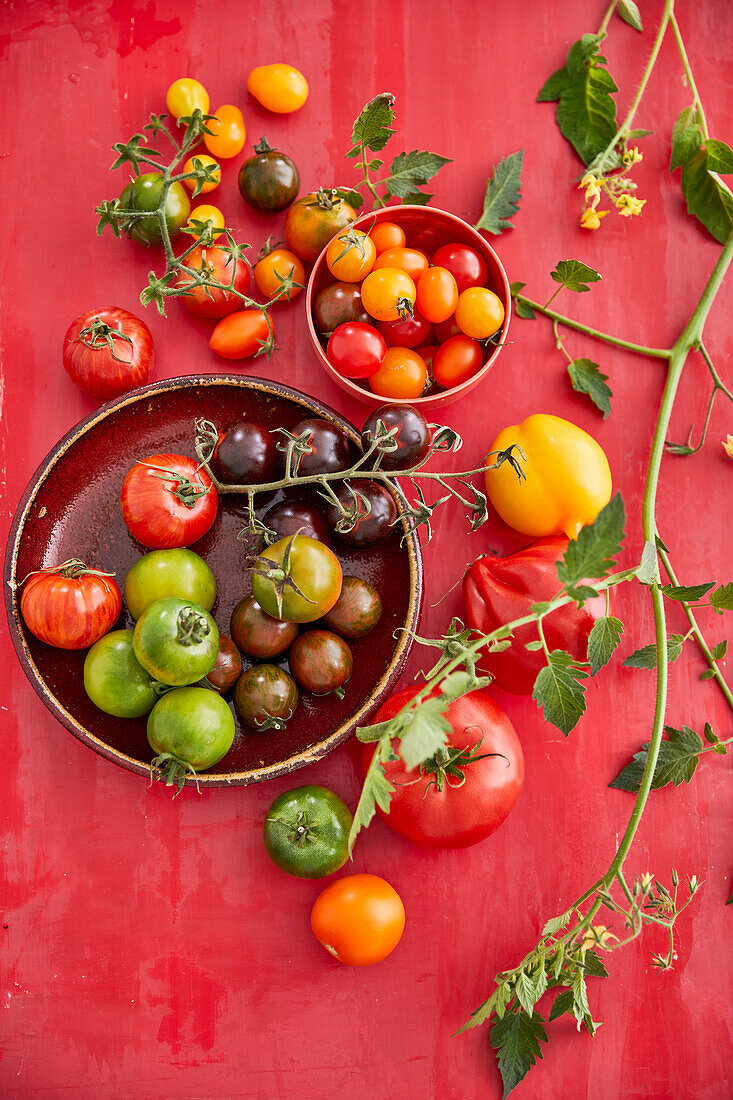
[4,375,423,787]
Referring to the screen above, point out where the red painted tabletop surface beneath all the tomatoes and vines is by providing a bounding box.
[0,0,733,1100]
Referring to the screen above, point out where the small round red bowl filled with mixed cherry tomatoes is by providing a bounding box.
[306,206,512,413]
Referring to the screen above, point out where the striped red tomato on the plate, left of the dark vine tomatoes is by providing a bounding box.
[120,454,219,550]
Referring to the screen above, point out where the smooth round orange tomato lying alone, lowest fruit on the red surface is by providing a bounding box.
[310,875,405,966]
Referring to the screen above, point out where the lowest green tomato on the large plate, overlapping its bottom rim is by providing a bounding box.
[147,688,234,782]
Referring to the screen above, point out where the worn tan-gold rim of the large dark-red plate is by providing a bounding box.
[4,374,423,787]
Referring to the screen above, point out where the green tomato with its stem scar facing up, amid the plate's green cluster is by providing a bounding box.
[132,596,219,688]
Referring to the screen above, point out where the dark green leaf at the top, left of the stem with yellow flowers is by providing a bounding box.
[537,34,619,164]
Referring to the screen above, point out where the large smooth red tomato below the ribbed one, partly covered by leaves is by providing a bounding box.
[362,684,524,848]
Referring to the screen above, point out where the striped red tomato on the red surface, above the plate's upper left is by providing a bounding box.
[63,306,154,400]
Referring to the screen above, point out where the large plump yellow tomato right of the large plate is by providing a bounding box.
[485,413,612,539]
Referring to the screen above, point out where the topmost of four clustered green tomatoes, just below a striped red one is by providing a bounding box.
[124,547,217,619]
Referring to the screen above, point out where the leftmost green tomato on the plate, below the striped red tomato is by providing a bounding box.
[84,630,158,718]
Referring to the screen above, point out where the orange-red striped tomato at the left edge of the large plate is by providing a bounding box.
[21,558,122,649]
